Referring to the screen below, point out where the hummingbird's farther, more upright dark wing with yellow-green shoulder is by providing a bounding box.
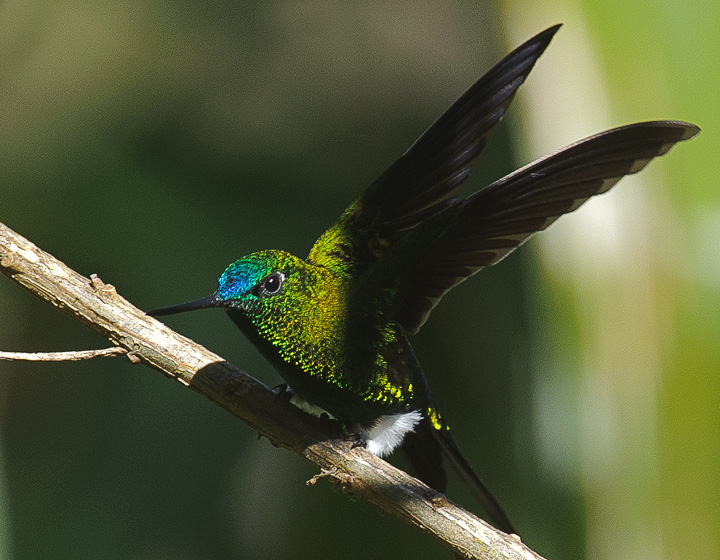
[308,25,560,276]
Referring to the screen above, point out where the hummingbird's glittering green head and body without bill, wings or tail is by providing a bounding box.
[216,251,422,422]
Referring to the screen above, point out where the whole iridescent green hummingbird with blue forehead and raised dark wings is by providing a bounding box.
[150,25,699,533]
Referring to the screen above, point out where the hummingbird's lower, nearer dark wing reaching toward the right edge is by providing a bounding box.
[390,121,700,333]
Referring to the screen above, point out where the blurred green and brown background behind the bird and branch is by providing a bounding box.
[0,0,720,560]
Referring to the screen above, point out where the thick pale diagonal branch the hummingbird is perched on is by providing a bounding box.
[0,223,542,560]
